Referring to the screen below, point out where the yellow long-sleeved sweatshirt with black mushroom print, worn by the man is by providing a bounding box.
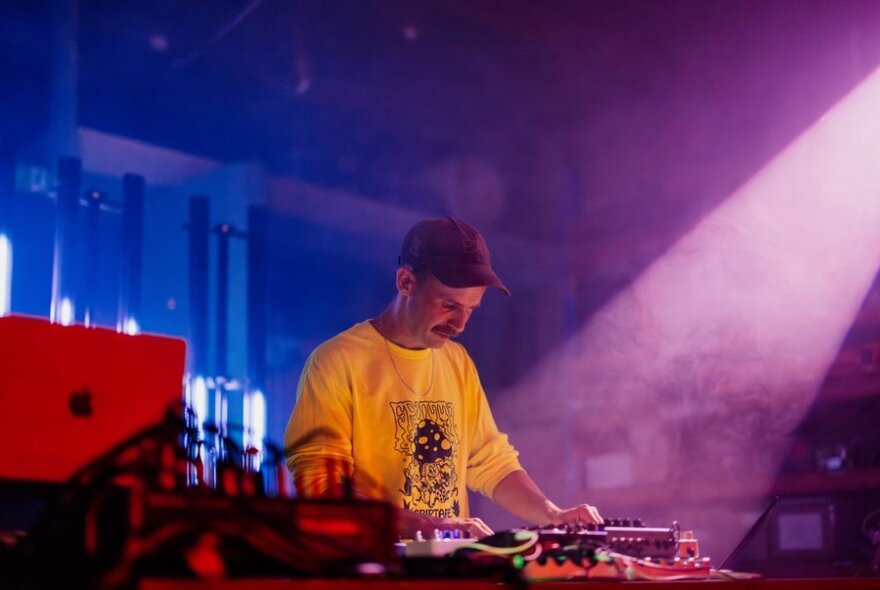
[284,322,522,518]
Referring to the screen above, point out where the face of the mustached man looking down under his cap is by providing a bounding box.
[402,269,486,348]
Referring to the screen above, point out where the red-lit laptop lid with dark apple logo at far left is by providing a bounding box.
[0,316,186,482]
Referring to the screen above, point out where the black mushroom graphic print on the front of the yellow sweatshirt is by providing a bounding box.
[390,401,461,518]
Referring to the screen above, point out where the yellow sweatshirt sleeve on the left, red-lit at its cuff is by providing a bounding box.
[284,348,354,497]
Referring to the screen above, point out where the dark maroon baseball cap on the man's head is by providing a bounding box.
[398,217,510,295]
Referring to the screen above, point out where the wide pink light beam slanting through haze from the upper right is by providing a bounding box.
[496,66,880,557]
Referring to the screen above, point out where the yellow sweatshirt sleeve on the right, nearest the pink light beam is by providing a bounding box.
[467,357,522,499]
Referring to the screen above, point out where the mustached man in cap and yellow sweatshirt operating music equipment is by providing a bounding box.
[284,217,602,537]
